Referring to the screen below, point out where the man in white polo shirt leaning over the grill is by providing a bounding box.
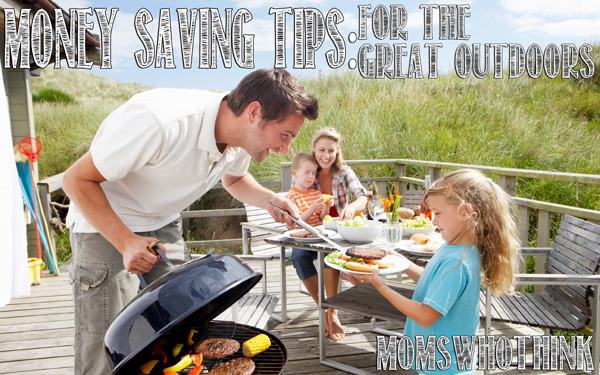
[63,70,318,374]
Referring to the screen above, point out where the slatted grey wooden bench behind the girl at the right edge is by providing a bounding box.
[482,215,600,330]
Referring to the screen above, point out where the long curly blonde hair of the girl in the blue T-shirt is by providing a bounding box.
[423,169,521,294]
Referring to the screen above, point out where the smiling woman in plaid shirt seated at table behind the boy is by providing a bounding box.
[292,128,368,341]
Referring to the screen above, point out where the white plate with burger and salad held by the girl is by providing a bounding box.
[325,246,410,275]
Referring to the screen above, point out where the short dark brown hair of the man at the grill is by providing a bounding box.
[227,69,319,122]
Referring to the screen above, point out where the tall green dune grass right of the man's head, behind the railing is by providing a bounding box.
[253,74,600,209]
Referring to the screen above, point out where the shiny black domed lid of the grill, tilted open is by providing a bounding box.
[104,255,262,374]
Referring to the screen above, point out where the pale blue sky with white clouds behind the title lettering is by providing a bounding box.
[55,0,600,90]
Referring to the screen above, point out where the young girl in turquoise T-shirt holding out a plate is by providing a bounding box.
[361,169,520,374]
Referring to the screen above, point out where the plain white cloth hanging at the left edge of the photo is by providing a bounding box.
[0,72,30,306]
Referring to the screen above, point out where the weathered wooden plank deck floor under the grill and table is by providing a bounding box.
[0,261,588,375]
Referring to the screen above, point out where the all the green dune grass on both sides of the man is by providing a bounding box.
[33,62,600,209]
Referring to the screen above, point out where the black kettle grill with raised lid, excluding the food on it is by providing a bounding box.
[104,255,287,375]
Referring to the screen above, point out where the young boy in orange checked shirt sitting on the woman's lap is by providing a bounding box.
[287,152,333,226]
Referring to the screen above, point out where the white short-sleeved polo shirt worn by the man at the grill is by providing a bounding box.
[67,89,250,233]
